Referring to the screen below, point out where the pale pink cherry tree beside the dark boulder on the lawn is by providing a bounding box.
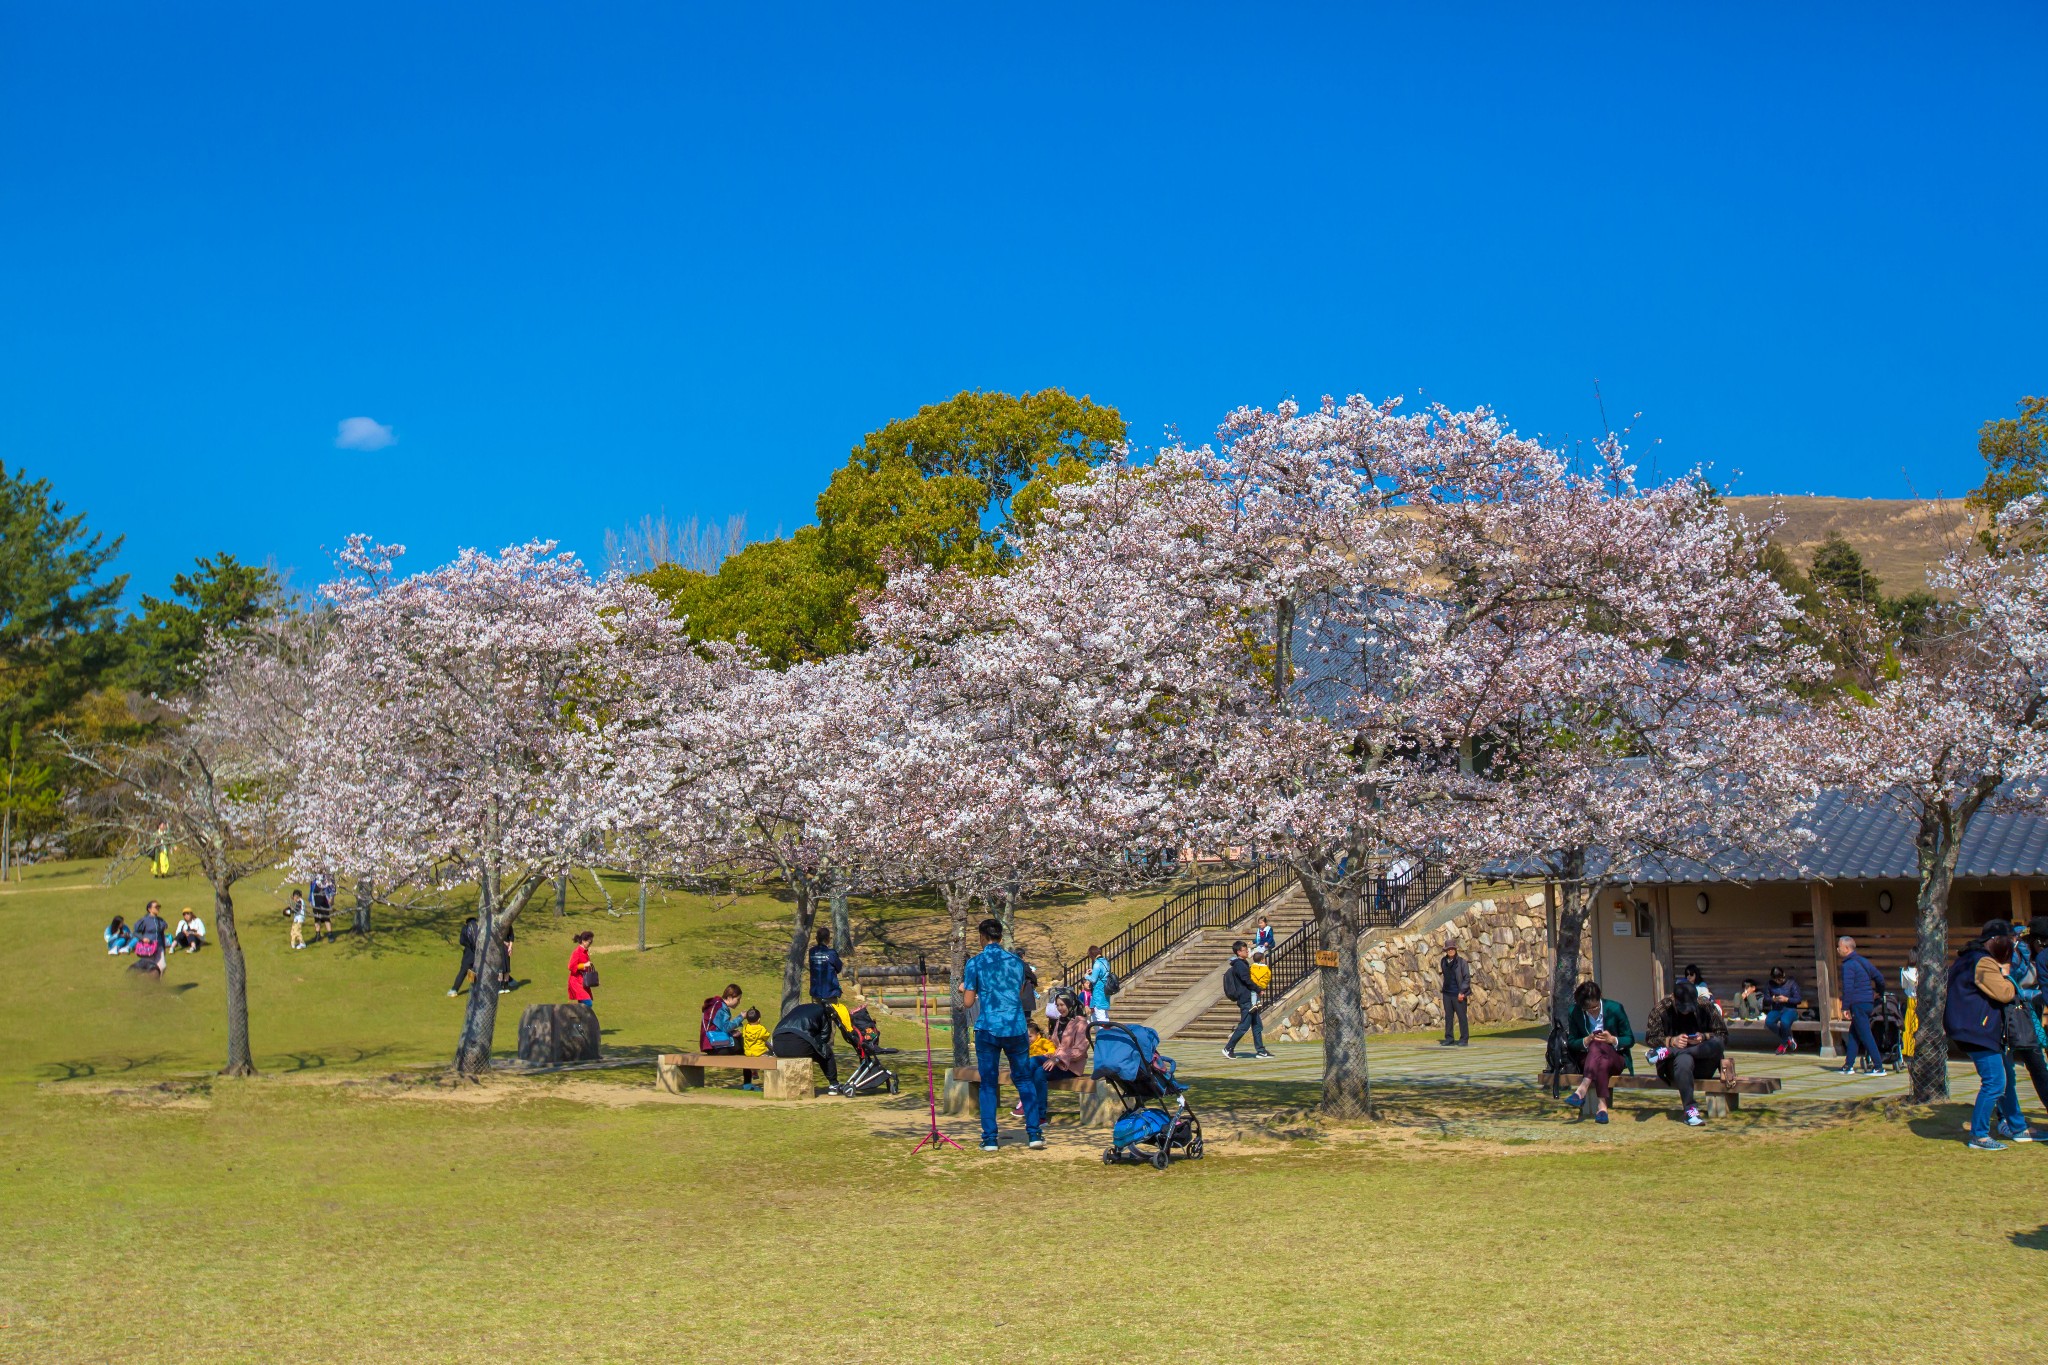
[293,536,731,1076]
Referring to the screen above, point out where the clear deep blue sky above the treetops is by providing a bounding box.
[0,2,2048,591]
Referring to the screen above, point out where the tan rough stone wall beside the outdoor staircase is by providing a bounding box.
[1280,890,1593,1042]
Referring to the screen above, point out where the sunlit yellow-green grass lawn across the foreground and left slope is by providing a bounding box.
[0,868,2048,1365]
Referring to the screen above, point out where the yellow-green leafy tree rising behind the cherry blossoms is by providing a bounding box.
[641,389,1124,667]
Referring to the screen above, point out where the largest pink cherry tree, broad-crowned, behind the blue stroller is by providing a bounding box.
[888,399,1818,1115]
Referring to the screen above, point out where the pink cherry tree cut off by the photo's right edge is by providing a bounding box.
[1786,499,2048,1103]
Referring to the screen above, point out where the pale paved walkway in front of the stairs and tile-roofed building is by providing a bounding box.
[1161,1036,1949,1107]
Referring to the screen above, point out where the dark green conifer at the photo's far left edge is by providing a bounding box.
[0,465,127,733]
